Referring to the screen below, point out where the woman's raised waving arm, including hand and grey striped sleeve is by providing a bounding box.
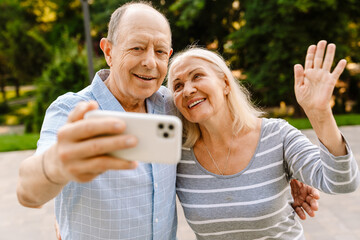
[284,40,360,194]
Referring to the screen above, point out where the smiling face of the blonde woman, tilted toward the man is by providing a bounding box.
[169,57,229,123]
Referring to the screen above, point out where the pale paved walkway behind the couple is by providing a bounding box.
[0,126,360,240]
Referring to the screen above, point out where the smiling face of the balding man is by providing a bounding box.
[109,8,172,104]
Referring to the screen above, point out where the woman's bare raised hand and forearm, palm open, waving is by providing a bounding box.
[294,40,346,156]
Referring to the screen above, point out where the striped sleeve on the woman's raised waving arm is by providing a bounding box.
[284,123,360,194]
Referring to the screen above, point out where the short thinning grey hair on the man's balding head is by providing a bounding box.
[107,1,171,45]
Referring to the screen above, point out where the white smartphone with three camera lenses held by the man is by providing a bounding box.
[85,110,182,164]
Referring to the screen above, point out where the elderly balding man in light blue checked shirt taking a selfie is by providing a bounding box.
[17,0,320,240]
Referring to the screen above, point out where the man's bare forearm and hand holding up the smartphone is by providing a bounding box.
[17,102,137,208]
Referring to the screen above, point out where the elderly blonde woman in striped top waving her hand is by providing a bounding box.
[168,41,360,239]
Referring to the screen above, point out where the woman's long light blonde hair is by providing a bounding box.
[167,47,263,147]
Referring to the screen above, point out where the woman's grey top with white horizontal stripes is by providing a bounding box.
[176,118,360,239]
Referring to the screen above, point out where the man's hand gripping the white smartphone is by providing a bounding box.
[44,101,137,185]
